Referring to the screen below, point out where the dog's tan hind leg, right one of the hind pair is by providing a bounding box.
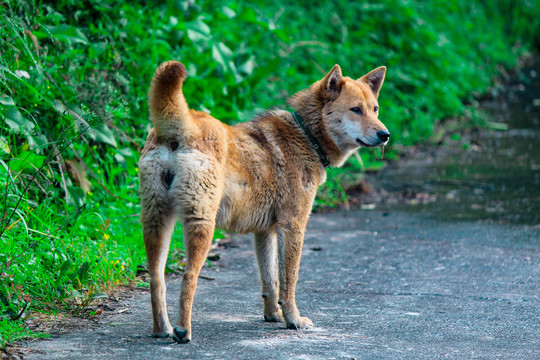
[173,221,215,343]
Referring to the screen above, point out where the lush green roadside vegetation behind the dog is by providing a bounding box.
[0,0,540,347]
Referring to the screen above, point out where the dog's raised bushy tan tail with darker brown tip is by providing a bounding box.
[148,60,193,137]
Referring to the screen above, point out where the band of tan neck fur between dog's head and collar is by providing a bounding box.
[288,83,344,166]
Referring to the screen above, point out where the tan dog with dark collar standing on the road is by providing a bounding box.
[139,61,390,343]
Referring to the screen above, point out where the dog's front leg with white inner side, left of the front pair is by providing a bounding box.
[255,229,283,322]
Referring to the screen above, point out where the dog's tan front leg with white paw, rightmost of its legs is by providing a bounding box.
[278,225,313,329]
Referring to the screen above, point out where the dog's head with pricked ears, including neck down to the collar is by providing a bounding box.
[290,65,390,165]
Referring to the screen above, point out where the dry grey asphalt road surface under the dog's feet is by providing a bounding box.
[25,211,540,359]
